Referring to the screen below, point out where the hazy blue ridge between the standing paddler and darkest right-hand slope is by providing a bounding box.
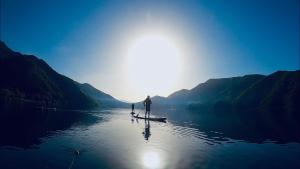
[143,75,265,109]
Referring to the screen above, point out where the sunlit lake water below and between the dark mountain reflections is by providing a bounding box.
[0,109,300,169]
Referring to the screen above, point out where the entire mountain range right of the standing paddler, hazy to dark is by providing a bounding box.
[153,70,300,113]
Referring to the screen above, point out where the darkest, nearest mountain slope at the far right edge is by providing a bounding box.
[233,70,300,113]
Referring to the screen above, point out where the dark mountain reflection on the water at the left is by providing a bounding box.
[0,105,100,148]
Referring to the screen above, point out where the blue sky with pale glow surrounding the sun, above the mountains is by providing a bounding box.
[1,0,300,101]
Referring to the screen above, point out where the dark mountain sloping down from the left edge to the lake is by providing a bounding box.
[0,41,97,109]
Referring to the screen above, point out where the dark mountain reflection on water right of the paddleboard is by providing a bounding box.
[162,110,300,144]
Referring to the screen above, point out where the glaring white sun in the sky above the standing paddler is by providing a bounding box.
[127,34,182,99]
